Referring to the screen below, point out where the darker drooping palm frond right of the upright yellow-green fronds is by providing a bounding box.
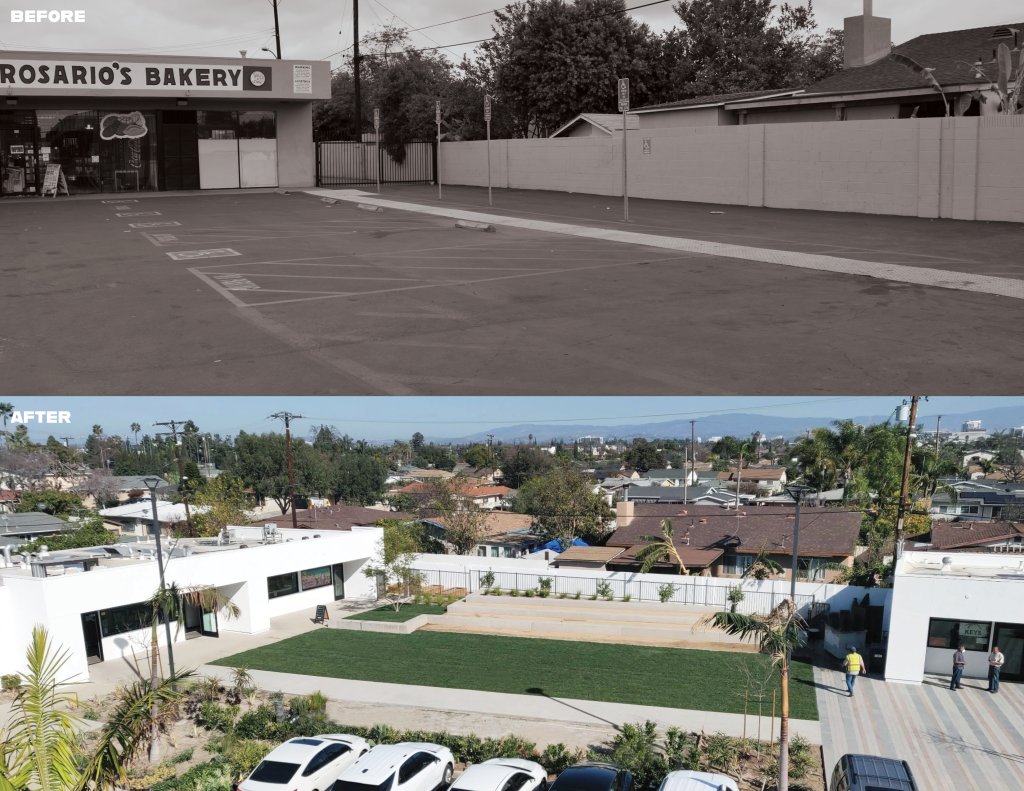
[75,670,195,791]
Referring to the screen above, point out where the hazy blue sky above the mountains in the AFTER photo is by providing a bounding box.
[0,396,1024,443]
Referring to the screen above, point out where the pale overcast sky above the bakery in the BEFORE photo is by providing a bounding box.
[0,0,1024,65]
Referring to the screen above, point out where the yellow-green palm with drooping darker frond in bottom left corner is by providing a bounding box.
[0,626,193,791]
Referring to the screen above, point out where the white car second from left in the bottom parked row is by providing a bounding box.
[333,742,455,791]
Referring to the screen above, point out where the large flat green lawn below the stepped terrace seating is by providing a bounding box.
[214,627,818,719]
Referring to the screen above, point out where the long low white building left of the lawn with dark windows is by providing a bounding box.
[0,527,383,680]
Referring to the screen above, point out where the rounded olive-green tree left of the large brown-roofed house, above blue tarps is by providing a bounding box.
[514,463,614,549]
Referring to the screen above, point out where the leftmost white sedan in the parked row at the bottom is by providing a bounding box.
[236,734,370,791]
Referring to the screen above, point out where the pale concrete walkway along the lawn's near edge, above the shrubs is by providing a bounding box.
[200,665,821,744]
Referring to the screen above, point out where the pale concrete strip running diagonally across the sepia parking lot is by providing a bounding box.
[306,190,1024,299]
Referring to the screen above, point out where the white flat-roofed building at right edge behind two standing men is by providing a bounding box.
[886,552,1024,683]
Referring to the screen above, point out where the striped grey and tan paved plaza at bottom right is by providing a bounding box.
[814,668,1024,791]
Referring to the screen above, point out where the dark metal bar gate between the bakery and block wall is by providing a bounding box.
[316,140,437,186]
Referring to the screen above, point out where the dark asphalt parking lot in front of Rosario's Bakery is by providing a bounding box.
[0,188,1024,396]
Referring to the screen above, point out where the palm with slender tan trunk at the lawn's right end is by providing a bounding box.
[700,598,805,791]
